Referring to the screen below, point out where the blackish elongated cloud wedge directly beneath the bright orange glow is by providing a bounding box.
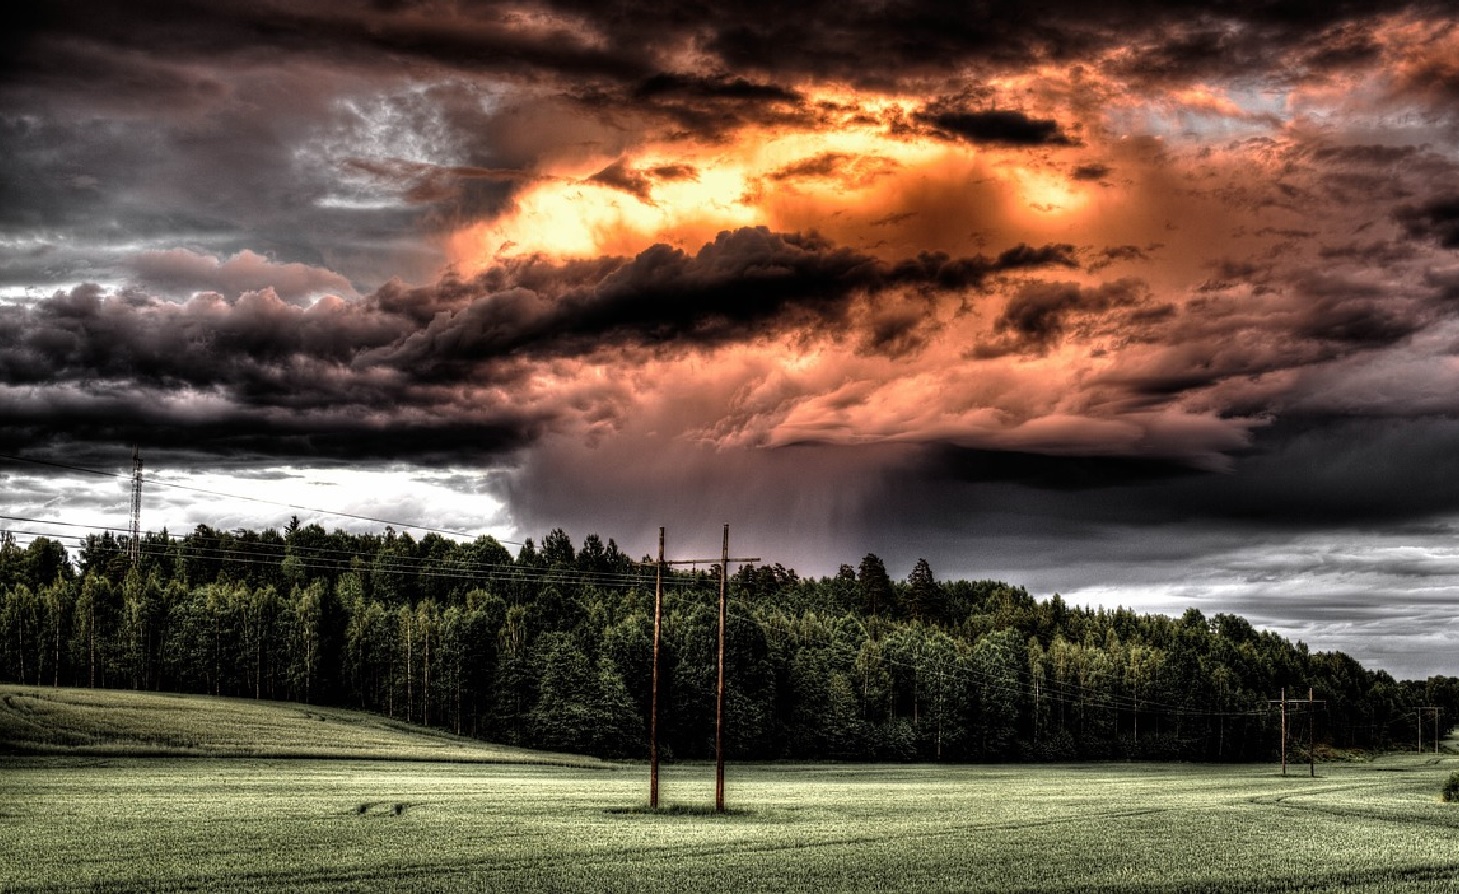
[371,228,1074,376]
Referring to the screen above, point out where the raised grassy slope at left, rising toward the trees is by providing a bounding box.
[0,685,604,767]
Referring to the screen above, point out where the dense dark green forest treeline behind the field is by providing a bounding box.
[0,519,1459,760]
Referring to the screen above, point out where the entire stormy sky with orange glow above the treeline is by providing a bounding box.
[0,0,1459,678]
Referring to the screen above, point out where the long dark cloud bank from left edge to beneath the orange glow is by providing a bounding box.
[0,229,1072,455]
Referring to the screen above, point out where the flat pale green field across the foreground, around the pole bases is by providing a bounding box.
[0,690,1459,894]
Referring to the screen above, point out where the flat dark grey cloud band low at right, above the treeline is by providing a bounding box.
[910,414,1459,531]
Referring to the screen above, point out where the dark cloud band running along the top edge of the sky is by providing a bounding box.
[7,0,1434,111]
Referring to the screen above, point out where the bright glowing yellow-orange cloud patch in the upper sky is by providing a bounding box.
[448,90,1099,273]
